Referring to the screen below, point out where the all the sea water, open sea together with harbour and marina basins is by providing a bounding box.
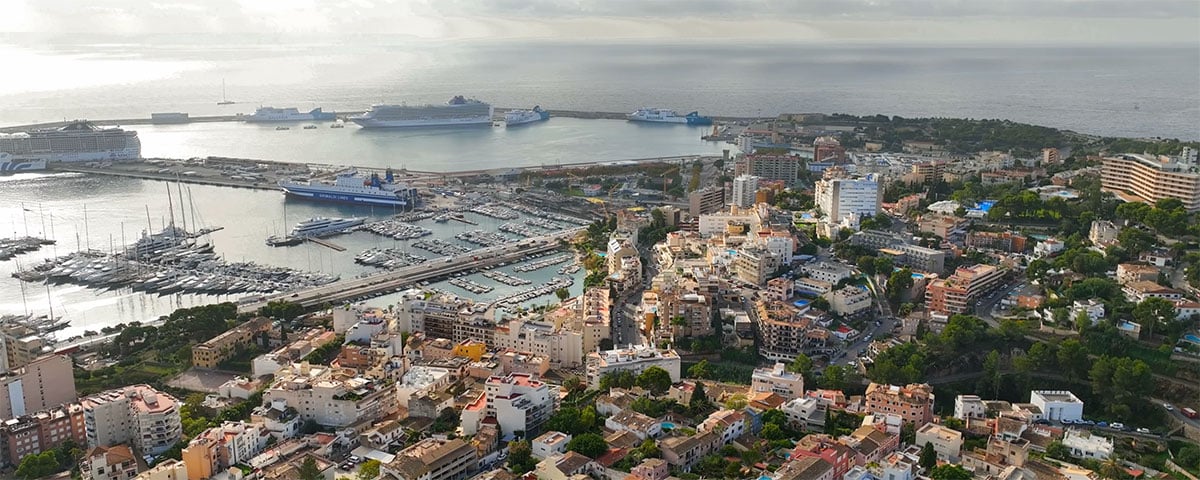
[0,34,1200,338]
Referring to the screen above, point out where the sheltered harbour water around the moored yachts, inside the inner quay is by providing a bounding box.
[0,174,583,338]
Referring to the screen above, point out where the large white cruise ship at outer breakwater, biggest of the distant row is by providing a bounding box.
[349,95,493,128]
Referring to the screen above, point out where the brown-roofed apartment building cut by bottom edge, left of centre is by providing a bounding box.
[379,438,479,480]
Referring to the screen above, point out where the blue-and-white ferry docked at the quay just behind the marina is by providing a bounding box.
[280,170,419,210]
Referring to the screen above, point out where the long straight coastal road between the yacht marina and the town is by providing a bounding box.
[238,227,583,313]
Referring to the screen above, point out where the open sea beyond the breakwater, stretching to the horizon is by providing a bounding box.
[0,35,1200,139]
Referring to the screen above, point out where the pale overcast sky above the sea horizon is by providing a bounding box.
[0,0,1200,46]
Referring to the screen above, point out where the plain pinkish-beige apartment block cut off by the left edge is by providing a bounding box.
[0,355,78,419]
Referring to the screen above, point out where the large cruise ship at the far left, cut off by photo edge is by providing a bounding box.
[0,120,142,162]
